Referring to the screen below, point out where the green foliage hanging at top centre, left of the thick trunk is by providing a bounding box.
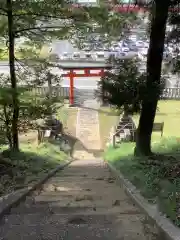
[74,4,138,45]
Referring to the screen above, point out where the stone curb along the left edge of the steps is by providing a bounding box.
[0,159,75,219]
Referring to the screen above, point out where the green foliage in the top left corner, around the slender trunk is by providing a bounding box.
[0,0,89,59]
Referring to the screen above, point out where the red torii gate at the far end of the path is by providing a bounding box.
[62,66,110,105]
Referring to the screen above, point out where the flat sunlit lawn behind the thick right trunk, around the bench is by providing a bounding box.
[133,100,180,141]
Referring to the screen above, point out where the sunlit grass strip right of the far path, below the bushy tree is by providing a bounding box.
[99,107,119,149]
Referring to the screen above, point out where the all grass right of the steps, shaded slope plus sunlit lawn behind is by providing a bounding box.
[104,101,180,226]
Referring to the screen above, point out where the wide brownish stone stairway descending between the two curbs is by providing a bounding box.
[0,159,158,240]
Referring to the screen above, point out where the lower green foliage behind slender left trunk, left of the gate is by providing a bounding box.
[0,63,62,148]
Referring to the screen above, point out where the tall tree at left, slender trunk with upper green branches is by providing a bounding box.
[0,0,88,150]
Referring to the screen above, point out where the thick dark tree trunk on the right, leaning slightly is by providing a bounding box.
[135,0,170,156]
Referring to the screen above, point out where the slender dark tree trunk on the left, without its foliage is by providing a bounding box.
[6,0,19,150]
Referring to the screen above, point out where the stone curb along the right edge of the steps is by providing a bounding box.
[105,161,180,240]
